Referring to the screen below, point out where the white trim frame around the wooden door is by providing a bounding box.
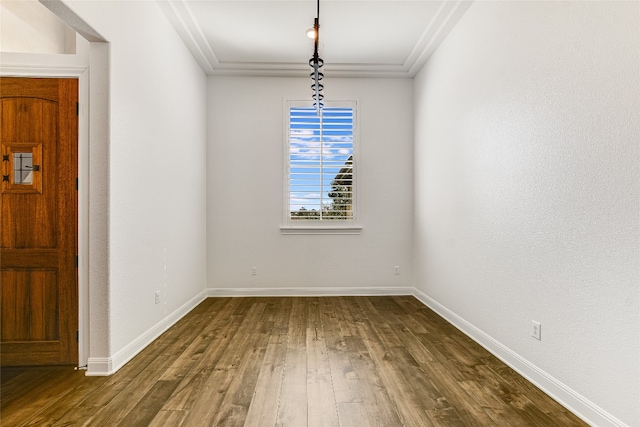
[0,57,89,368]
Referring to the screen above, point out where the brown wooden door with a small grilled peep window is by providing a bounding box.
[0,78,78,366]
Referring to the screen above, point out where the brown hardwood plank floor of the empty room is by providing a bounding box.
[0,297,586,427]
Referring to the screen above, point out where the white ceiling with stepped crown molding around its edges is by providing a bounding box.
[157,0,471,77]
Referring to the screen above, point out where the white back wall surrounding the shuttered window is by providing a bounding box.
[207,77,413,295]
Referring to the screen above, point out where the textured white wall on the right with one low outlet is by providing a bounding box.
[414,1,640,426]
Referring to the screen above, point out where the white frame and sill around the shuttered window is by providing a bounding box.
[280,100,362,234]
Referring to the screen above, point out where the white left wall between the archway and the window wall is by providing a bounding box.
[66,1,207,374]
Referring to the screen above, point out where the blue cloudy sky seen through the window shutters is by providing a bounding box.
[289,107,353,216]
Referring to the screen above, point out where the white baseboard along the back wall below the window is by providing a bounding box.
[207,287,414,297]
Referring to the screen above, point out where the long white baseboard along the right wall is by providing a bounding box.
[413,289,629,427]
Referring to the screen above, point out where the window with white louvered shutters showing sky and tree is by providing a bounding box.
[283,102,357,234]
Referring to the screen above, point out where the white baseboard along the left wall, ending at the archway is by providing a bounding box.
[86,291,207,376]
